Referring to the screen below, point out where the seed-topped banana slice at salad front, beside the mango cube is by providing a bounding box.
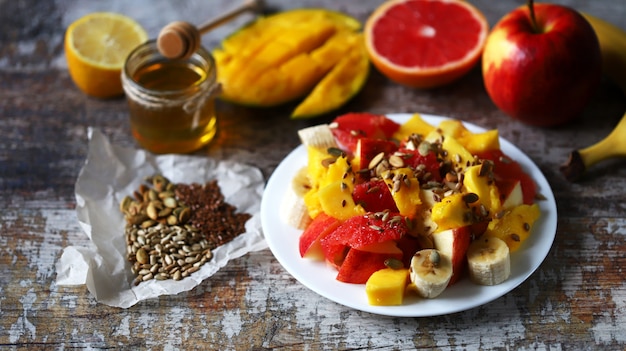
[409,249,452,299]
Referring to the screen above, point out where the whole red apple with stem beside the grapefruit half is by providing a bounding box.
[482,0,601,127]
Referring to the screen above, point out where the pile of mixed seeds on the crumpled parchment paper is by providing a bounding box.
[120,175,250,285]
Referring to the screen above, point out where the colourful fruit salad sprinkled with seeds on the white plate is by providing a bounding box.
[283,113,541,305]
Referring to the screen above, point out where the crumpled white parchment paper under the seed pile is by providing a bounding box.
[56,128,267,308]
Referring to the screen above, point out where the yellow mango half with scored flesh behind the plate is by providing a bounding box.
[213,9,370,118]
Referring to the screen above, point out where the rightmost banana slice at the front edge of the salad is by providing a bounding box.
[467,237,511,285]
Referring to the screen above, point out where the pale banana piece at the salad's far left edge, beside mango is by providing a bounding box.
[280,167,311,229]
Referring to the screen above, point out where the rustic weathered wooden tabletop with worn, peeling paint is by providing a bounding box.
[0,0,626,350]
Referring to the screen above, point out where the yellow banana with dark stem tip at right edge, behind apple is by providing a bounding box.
[561,13,626,181]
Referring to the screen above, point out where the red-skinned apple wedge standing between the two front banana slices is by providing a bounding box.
[433,226,471,285]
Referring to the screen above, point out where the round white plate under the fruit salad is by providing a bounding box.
[261,114,557,317]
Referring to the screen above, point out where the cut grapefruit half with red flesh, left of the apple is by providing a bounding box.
[364,0,489,88]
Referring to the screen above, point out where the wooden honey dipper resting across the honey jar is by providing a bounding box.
[157,0,262,59]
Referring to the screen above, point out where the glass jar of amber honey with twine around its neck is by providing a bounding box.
[122,40,219,154]
